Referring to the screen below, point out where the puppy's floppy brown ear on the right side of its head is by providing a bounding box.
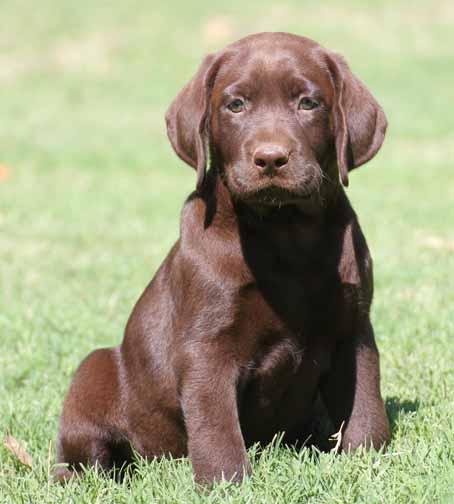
[328,53,388,186]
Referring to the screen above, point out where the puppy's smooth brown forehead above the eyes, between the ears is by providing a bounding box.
[215,34,331,96]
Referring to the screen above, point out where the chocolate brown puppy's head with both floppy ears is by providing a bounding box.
[166,33,387,209]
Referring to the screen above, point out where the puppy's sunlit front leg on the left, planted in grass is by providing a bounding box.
[180,343,251,483]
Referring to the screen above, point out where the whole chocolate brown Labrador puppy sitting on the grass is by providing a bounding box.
[57,33,390,482]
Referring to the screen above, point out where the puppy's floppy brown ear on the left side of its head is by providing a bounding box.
[166,54,220,189]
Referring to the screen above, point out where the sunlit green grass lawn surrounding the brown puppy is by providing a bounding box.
[0,0,454,504]
